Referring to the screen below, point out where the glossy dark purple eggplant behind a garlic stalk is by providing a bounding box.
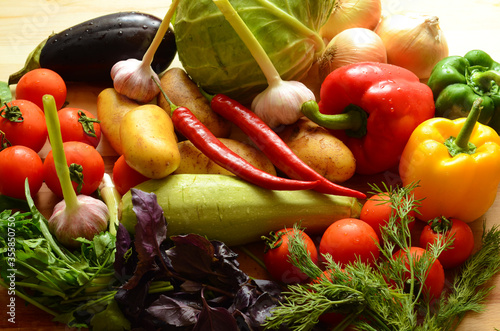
[8,11,177,85]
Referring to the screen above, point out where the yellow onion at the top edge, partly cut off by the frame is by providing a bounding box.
[319,0,382,41]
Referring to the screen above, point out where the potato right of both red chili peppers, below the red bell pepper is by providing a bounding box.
[278,117,356,183]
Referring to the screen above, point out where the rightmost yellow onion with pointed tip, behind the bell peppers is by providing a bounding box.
[375,13,448,80]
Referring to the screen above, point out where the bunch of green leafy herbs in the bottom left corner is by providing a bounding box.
[0,188,126,327]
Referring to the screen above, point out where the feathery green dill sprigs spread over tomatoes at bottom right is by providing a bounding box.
[265,185,500,331]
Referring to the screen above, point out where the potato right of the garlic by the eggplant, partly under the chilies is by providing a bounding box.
[158,68,231,138]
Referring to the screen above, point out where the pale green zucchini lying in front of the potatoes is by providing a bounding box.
[120,174,361,246]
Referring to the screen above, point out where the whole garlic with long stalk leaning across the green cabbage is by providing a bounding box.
[213,0,315,127]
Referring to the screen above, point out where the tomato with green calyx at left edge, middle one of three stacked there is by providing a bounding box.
[0,100,48,153]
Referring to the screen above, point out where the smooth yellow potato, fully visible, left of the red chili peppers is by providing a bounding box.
[120,104,181,179]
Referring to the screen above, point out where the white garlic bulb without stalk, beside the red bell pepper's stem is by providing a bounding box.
[251,79,316,128]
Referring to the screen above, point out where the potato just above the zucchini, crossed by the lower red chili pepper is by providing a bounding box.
[174,138,276,176]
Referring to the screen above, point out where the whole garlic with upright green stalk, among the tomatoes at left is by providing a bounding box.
[43,95,109,248]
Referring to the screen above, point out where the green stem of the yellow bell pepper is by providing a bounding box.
[444,98,483,157]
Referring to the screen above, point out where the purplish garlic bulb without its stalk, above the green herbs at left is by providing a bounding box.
[48,195,109,248]
